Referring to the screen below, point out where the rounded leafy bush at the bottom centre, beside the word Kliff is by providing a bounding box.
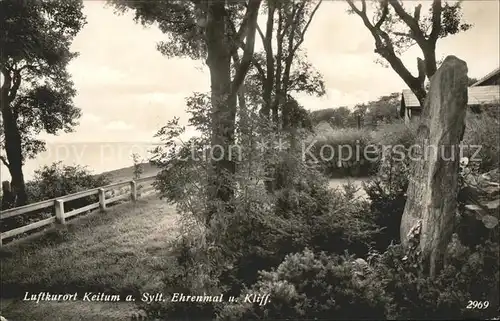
[217,249,389,321]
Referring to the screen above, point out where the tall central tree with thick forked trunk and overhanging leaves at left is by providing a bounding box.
[110,0,261,223]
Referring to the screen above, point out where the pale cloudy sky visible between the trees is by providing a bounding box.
[2,0,500,180]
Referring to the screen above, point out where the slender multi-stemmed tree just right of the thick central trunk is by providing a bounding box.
[242,0,325,192]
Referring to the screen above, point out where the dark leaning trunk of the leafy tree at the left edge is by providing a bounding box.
[0,88,28,206]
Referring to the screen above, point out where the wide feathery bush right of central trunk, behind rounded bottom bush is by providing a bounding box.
[213,162,379,294]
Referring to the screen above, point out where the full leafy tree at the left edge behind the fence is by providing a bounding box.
[0,0,85,206]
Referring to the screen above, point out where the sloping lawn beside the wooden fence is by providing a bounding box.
[1,195,178,321]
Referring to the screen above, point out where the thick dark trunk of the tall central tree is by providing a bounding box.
[206,1,237,224]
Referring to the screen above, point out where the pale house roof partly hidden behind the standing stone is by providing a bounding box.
[401,86,500,109]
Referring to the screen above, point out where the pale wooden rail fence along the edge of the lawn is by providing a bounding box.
[0,176,156,246]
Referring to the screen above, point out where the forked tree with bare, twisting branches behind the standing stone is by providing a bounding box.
[346,0,471,106]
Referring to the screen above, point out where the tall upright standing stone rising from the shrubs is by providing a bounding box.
[401,56,468,277]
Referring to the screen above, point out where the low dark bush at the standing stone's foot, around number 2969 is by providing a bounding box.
[374,239,500,320]
